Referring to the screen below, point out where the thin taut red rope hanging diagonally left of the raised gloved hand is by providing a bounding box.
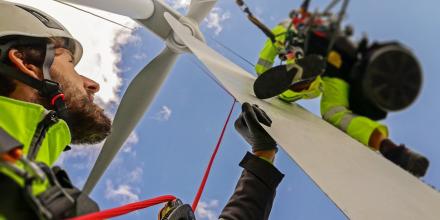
[192,99,236,212]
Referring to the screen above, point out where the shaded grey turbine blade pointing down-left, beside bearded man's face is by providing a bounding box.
[84,47,178,193]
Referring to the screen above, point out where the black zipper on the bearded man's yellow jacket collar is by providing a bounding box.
[27,111,58,160]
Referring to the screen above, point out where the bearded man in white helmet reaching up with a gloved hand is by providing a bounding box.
[0,0,283,220]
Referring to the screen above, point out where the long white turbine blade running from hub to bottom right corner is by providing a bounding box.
[165,12,440,220]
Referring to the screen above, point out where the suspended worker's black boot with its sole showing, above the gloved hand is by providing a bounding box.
[254,55,325,99]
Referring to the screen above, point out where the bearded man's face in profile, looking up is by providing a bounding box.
[51,48,111,144]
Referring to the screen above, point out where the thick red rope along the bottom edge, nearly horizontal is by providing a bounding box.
[69,195,176,220]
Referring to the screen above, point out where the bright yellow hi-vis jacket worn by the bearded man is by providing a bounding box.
[0,96,71,195]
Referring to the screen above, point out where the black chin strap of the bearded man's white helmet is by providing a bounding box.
[0,43,68,119]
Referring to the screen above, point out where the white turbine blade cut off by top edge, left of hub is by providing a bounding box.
[60,0,154,19]
